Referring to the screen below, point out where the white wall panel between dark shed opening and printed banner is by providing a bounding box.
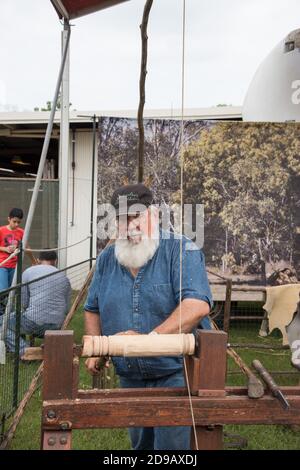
[67,129,98,287]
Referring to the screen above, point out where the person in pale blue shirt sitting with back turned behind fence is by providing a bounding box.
[0,251,71,356]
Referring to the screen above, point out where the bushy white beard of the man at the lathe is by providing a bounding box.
[115,238,159,269]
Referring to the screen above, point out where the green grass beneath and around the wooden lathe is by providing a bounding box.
[4,309,300,450]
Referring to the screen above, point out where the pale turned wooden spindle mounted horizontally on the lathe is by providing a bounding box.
[82,333,195,357]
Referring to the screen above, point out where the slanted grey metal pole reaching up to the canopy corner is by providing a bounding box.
[0,20,71,364]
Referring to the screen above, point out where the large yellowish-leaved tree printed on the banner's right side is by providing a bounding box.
[176,122,300,278]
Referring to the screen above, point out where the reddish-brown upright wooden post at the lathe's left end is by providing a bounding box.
[41,330,78,450]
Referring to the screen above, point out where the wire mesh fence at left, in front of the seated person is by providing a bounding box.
[0,259,90,442]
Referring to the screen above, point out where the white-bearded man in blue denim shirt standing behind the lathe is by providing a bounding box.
[85,184,212,450]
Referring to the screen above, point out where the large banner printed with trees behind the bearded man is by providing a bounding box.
[98,118,300,292]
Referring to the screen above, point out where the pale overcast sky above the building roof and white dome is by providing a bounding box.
[0,0,300,111]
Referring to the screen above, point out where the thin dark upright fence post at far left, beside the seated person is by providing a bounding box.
[10,242,23,408]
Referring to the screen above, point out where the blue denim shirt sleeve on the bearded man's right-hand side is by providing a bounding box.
[172,240,213,308]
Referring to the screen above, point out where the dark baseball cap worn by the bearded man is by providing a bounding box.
[111,183,153,215]
